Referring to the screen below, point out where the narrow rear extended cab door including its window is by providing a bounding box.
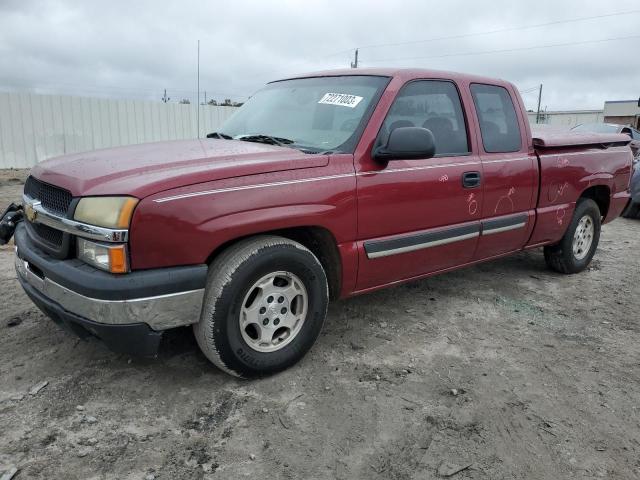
[470,83,538,259]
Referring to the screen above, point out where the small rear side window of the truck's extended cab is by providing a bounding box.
[471,84,522,153]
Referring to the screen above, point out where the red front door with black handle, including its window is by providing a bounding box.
[356,80,482,290]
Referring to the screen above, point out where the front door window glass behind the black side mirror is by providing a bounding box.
[379,80,469,157]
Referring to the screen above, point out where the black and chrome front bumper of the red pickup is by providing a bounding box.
[15,225,207,354]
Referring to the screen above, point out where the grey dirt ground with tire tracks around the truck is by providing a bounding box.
[0,171,640,480]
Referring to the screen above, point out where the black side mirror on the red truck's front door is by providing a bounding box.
[373,127,436,162]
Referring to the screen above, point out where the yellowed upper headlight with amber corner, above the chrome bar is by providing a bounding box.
[73,197,138,228]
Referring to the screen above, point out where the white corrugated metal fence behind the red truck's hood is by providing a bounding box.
[0,93,236,168]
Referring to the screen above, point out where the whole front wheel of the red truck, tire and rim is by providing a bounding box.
[194,236,329,378]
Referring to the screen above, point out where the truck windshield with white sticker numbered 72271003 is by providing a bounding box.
[218,75,389,153]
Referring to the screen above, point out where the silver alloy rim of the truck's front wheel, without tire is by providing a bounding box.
[238,271,309,353]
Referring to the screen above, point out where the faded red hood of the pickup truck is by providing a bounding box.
[31,139,328,198]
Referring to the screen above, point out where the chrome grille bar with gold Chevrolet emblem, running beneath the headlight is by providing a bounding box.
[22,195,129,242]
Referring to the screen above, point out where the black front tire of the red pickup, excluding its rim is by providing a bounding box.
[193,236,329,378]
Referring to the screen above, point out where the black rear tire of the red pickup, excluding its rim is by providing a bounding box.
[544,198,601,274]
